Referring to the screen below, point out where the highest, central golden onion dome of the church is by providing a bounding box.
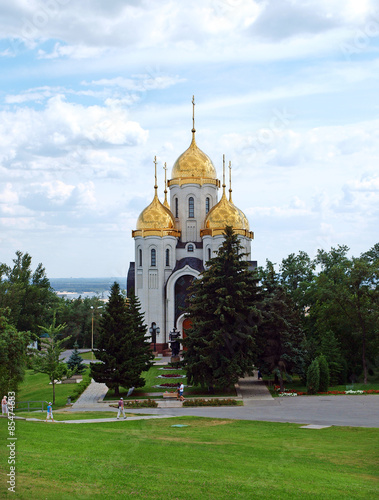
[169,130,219,186]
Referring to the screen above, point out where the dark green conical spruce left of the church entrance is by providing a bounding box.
[91,282,154,396]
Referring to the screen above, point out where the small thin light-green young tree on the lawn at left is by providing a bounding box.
[33,315,68,404]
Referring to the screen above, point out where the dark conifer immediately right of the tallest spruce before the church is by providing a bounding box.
[258,261,305,391]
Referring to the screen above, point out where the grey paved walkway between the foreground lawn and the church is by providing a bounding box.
[55,370,379,428]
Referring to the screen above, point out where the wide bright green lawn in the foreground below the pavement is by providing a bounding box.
[0,417,379,500]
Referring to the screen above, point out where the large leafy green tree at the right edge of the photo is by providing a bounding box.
[312,244,379,384]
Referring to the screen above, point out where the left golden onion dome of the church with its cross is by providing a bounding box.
[132,158,180,238]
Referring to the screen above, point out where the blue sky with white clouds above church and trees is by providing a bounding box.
[0,0,379,278]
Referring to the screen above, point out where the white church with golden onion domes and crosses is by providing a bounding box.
[127,99,256,354]
